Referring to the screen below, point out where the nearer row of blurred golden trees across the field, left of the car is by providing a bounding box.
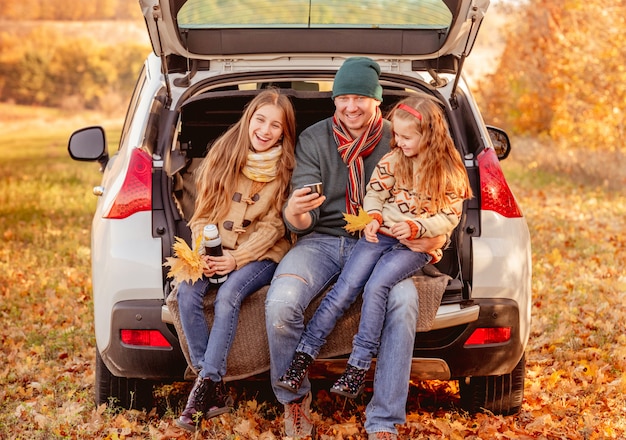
[0,27,149,108]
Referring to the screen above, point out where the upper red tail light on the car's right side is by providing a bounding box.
[478,148,522,218]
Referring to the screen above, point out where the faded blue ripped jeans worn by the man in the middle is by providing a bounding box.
[265,232,417,432]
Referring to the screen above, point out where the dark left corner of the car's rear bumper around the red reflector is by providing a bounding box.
[100,300,187,380]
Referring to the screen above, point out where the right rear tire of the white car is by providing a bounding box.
[459,355,526,416]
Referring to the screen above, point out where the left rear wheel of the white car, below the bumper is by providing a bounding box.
[95,348,154,410]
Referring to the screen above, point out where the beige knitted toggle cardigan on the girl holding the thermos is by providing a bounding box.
[191,174,289,269]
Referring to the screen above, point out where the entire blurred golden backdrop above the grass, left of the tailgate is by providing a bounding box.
[0,0,150,114]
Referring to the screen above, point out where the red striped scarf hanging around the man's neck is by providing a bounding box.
[333,108,383,214]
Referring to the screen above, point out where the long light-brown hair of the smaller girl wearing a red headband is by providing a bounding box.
[389,97,472,213]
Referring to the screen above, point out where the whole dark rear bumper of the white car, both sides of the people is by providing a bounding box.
[101,299,525,380]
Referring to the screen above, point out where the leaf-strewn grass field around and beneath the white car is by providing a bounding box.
[0,106,626,440]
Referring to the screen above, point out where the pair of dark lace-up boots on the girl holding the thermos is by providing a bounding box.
[176,376,232,431]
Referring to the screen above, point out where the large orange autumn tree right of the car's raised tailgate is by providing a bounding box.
[472,0,626,151]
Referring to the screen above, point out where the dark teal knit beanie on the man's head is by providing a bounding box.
[332,57,383,101]
